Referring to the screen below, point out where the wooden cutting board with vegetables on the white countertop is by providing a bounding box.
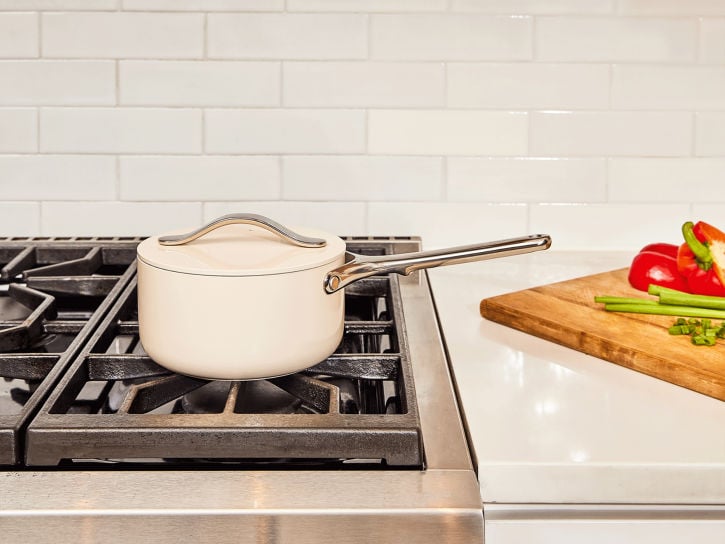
[481,268,725,400]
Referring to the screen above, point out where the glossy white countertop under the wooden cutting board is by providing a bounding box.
[429,250,725,505]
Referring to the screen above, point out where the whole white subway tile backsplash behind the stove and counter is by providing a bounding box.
[0,0,725,250]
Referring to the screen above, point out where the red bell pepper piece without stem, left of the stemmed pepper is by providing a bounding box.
[629,243,689,292]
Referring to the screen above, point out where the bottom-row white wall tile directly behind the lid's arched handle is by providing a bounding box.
[204,201,366,236]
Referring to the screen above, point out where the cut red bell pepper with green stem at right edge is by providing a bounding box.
[677,221,725,297]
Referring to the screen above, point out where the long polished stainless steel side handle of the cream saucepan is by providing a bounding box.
[325,234,551,293]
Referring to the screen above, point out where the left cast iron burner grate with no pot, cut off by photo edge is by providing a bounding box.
[0,238,141,465]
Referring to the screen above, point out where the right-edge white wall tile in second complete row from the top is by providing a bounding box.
[612,65,725,110]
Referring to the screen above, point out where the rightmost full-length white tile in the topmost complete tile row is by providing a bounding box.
[535,17,697,62]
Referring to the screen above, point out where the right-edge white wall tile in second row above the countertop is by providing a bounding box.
[609,157,725,202]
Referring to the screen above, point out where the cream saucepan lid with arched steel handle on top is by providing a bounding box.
[137,213,345,276]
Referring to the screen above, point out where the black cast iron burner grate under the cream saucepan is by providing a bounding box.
[26,241,424,468]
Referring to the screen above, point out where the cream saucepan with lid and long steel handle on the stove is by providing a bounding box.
[137,214,551,380]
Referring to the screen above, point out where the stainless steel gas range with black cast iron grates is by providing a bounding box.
[0,238,483,544]
